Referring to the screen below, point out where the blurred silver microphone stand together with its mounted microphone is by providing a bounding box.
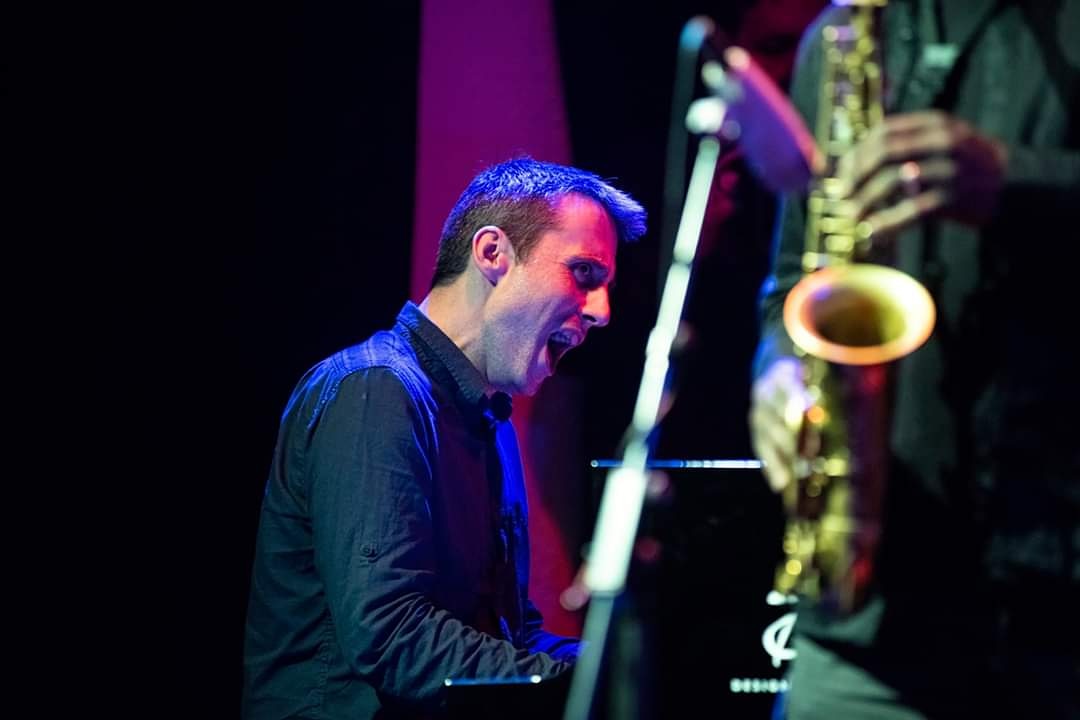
[564,17,823,720]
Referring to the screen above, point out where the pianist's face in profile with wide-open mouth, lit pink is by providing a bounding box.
[484,195,618,395]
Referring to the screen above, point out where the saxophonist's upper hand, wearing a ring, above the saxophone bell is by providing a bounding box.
[837,110,1009,240]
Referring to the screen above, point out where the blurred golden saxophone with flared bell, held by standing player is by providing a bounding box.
[775,0,934,613]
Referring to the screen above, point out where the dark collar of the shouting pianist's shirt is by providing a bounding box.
[397,301,512,425]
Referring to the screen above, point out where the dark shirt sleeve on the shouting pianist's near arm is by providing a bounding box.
[309,368,568,704]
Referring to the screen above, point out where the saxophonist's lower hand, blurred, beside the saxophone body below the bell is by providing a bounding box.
[750,357,816,492]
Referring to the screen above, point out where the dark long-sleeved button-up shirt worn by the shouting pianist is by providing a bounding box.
[244,303,578,719]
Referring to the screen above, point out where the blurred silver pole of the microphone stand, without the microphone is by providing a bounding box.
[564,108,720,720]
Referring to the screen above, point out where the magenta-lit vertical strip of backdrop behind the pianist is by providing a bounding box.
[411,0,585,635]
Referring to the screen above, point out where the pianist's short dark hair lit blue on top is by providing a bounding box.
[431,157,646,287]
